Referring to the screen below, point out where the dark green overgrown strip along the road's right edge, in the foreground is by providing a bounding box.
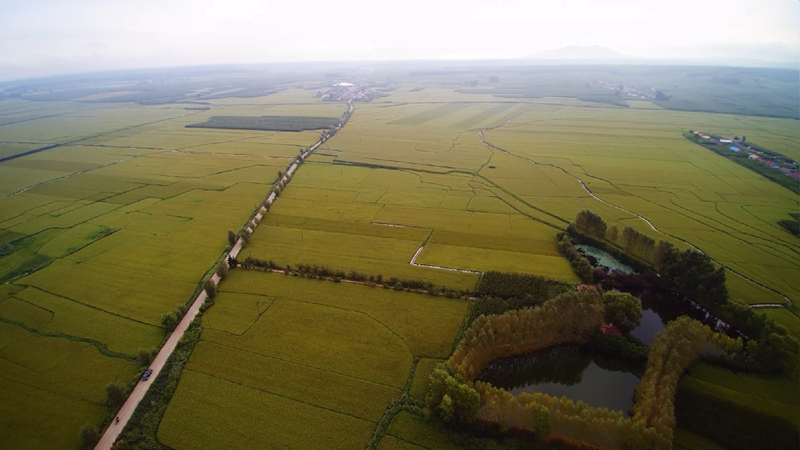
[114,316,202,450]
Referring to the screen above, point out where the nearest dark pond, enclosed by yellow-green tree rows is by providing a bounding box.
[478,346,639,417]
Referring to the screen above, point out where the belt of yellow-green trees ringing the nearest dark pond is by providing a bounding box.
[426,312,724,450]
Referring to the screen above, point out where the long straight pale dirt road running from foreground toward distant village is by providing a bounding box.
[95,101,353,450]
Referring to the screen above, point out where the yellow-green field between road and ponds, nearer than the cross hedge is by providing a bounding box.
[158,270,467,448]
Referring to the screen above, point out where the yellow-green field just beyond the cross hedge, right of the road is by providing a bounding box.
[243,160,577,289]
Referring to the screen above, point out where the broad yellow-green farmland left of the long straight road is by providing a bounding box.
[0,97,334,448]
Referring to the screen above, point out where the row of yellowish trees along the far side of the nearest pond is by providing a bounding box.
[448,291,604,380]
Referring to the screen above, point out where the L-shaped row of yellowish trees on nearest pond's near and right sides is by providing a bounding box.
[446,317,712,450]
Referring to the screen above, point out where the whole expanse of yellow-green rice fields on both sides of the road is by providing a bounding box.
[0,67,800,450]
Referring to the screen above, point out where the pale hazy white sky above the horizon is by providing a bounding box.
[0,0,800,80]
